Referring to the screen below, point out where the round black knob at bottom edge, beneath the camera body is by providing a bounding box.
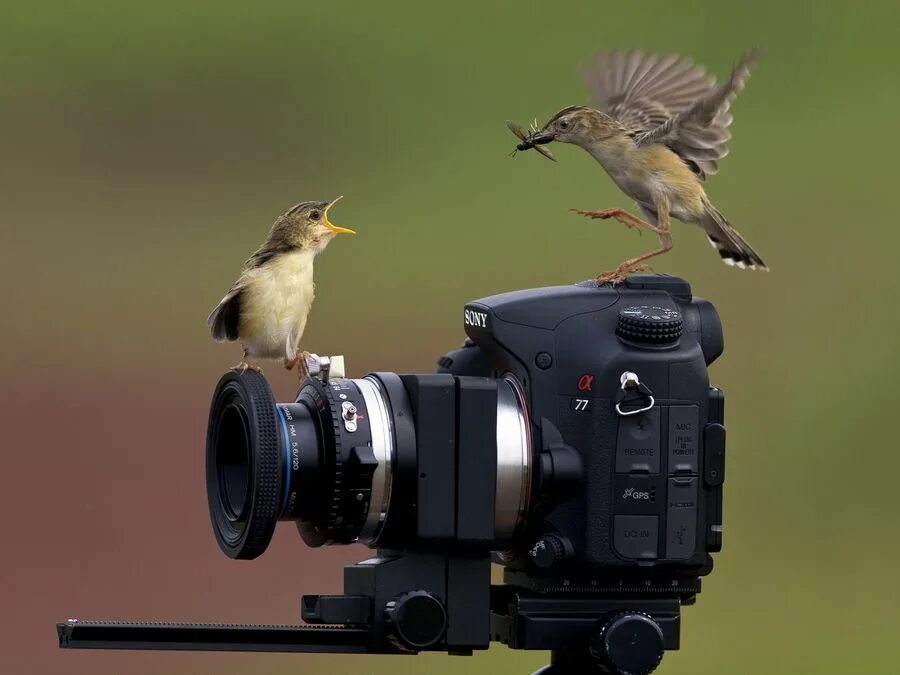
[591,611,664,675]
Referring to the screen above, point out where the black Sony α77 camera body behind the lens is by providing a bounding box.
[442,276,724,577]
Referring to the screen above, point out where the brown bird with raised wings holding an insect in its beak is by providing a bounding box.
[514,50,768,284]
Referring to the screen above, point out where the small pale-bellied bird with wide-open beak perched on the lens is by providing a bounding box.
[207,197,356,378]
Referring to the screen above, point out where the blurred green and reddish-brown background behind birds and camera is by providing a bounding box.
[0,0,900,675]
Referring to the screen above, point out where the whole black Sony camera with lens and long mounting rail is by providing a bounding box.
[58,275,725,674]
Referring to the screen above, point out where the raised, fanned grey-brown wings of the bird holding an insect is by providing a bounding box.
[585,50,760,178]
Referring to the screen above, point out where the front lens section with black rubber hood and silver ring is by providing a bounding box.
[206,370,394,559]
